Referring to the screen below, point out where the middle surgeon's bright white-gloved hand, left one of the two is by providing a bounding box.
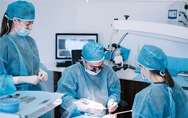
[77,99,106,115]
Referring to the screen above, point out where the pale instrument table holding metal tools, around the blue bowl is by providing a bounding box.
[0,91,63,118]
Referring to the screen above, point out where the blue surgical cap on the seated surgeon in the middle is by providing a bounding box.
[82,42,104,63]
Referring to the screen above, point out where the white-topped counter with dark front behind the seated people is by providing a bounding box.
[45,64,188,118]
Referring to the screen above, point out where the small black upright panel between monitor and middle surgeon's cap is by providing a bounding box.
[71,50,82,64]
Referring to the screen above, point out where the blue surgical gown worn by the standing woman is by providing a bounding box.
[0,34,42,95]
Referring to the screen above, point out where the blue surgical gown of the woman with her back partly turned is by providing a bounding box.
[132,83,188,118]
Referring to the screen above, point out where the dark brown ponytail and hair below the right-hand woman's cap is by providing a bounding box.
[151,69,174,87]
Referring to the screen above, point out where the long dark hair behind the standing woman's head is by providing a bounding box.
[0,14,13,37]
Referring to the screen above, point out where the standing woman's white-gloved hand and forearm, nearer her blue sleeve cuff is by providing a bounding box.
[13,75,40,85]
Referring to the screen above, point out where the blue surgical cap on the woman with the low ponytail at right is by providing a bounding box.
[137,45,167,72]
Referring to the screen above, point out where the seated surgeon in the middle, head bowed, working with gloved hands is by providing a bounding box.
[57,42,120,118]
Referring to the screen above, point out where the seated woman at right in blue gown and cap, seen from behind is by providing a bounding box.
[132,45,188,118]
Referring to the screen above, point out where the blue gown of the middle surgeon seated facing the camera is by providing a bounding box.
[57,63,120,117]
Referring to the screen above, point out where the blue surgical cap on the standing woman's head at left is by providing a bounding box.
[6,1,35,21]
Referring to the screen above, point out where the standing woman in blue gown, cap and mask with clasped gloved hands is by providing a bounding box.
[0,1,48,96]
